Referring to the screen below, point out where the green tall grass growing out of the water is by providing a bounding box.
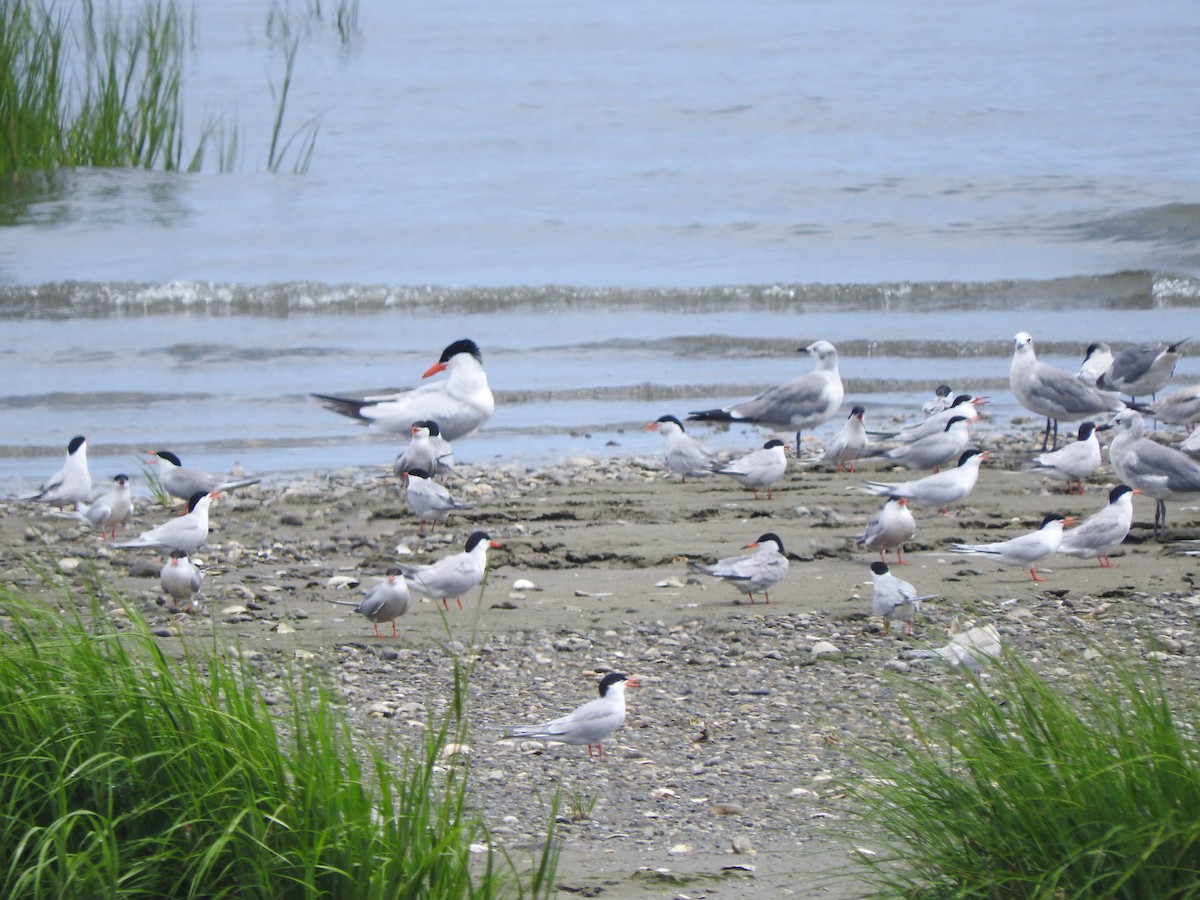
[0,0,194,173]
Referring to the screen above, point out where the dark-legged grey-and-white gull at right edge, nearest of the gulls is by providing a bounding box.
[1109,409,1200,538]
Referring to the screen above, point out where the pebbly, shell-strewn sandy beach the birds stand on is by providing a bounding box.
[0,422,1200,898]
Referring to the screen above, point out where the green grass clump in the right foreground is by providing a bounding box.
[848,659,1200,900]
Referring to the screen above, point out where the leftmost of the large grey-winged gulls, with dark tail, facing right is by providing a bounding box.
[688,341,845,450]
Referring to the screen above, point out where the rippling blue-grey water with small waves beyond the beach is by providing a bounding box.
[0,0,1200,488]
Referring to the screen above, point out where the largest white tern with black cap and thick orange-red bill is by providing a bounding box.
[312,340,496,440]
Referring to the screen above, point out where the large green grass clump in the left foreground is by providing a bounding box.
[0,580,554,900]
